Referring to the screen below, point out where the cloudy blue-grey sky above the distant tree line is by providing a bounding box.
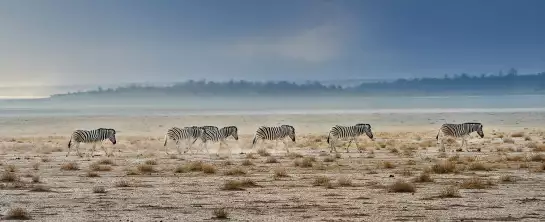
[0,0,545,86]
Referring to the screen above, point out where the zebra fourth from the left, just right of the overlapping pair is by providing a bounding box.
[252,125,295,153]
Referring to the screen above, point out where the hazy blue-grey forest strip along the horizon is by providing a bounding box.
[52,69,545,97]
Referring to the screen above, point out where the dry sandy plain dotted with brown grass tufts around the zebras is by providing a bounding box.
[0,113,545,221]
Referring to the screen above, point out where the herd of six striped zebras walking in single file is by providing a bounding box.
[66,123,484,157]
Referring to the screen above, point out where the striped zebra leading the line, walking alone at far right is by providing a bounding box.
[435,123,484,152]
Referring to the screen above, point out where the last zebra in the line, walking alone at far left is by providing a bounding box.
[66,128,117,157]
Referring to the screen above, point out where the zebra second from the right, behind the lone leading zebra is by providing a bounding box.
[327,123,375,153]
